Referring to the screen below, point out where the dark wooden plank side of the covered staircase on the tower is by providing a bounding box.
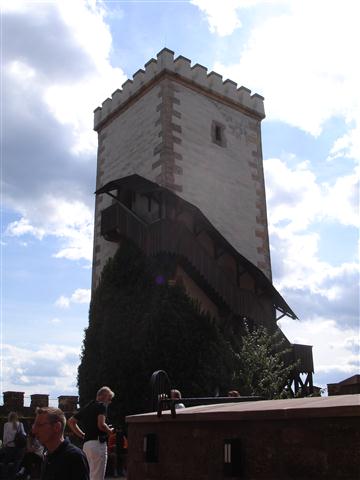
[101,203,313,372]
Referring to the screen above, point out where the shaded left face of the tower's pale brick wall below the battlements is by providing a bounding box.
[93,85,161,287]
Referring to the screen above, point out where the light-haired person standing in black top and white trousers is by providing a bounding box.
[68,387,115,480]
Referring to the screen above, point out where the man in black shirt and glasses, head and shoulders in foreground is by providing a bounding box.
[32,407,89,480]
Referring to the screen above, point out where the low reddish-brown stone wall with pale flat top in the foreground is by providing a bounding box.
[127,395,360,480]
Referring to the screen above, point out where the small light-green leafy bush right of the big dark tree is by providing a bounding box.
[235,325,296,399]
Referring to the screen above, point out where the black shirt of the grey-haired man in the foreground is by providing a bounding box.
[41,440,90,480]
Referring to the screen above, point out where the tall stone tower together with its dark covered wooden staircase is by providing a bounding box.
[93,49,314,393]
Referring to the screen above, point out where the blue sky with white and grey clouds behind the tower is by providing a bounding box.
[0,0,360,398]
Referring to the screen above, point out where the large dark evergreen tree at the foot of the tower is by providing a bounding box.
[78,238,233,419]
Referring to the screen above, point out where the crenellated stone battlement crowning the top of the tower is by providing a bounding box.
[94,48,265,130]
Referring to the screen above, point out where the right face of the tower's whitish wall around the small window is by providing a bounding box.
[173,84,271,277]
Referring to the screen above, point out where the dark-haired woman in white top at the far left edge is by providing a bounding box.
[0,412,26,478]
